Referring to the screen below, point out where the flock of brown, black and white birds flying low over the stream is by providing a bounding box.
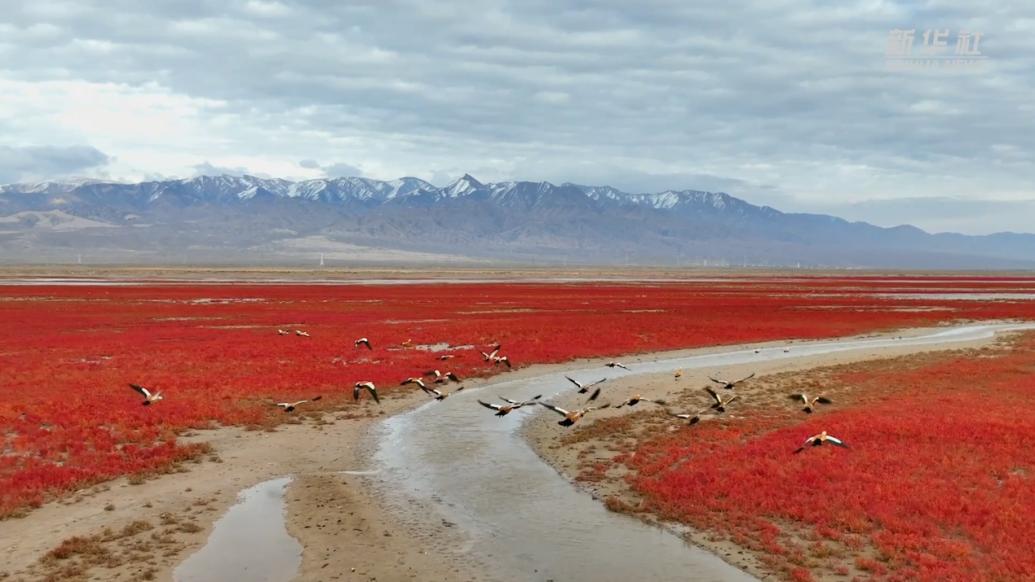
[129,328,848,453]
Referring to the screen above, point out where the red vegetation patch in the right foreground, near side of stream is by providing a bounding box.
[619,334,1035,581]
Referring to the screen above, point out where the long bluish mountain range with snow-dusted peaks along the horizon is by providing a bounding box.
[0,175,1035,268]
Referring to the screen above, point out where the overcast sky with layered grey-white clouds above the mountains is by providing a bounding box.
[0,0,1035,233]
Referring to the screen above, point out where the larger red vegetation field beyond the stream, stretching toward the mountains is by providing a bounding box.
[0,279,1035,517]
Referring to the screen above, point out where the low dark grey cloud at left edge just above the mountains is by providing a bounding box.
[0,145,111,183]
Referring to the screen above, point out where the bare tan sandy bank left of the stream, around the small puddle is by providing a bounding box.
[0,385,469,580]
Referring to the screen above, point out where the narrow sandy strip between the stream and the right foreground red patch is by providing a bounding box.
[523,323,1018,580]
